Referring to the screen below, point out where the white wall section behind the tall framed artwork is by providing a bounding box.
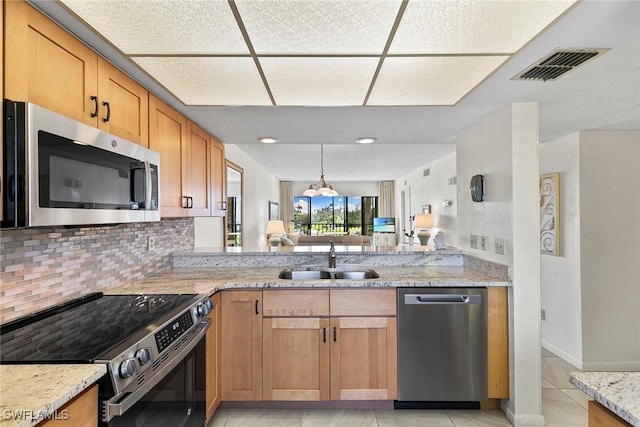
[540,133,582,369]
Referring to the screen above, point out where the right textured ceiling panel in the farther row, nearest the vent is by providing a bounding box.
[367,56,509,105]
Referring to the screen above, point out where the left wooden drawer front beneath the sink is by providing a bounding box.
[262,289,329,317]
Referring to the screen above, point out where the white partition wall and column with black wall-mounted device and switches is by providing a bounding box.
[456,103,544,427]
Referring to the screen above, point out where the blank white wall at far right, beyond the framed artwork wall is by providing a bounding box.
[580,131,640,370]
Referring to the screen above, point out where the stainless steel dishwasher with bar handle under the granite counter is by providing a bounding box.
[396,288,487,408]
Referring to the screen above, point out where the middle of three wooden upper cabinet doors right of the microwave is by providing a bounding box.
[185,122,211,216]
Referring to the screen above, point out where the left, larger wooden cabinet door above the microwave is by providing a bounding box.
[3,1,98,126]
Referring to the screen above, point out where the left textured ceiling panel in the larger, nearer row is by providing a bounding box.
[62,0,249,54]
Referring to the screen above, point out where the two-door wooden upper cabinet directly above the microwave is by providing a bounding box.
[4,1,149,147]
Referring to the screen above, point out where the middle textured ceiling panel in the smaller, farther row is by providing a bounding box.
[260,58,378,106]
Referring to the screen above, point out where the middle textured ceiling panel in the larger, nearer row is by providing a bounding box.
[236,0,401,54]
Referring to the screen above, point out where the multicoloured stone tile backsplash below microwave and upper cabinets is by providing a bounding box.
[0,219,194,323]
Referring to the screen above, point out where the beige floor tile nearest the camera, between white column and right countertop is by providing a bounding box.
[542,389,589,427]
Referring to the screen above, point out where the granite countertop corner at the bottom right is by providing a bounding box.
[571,372,640,426]
